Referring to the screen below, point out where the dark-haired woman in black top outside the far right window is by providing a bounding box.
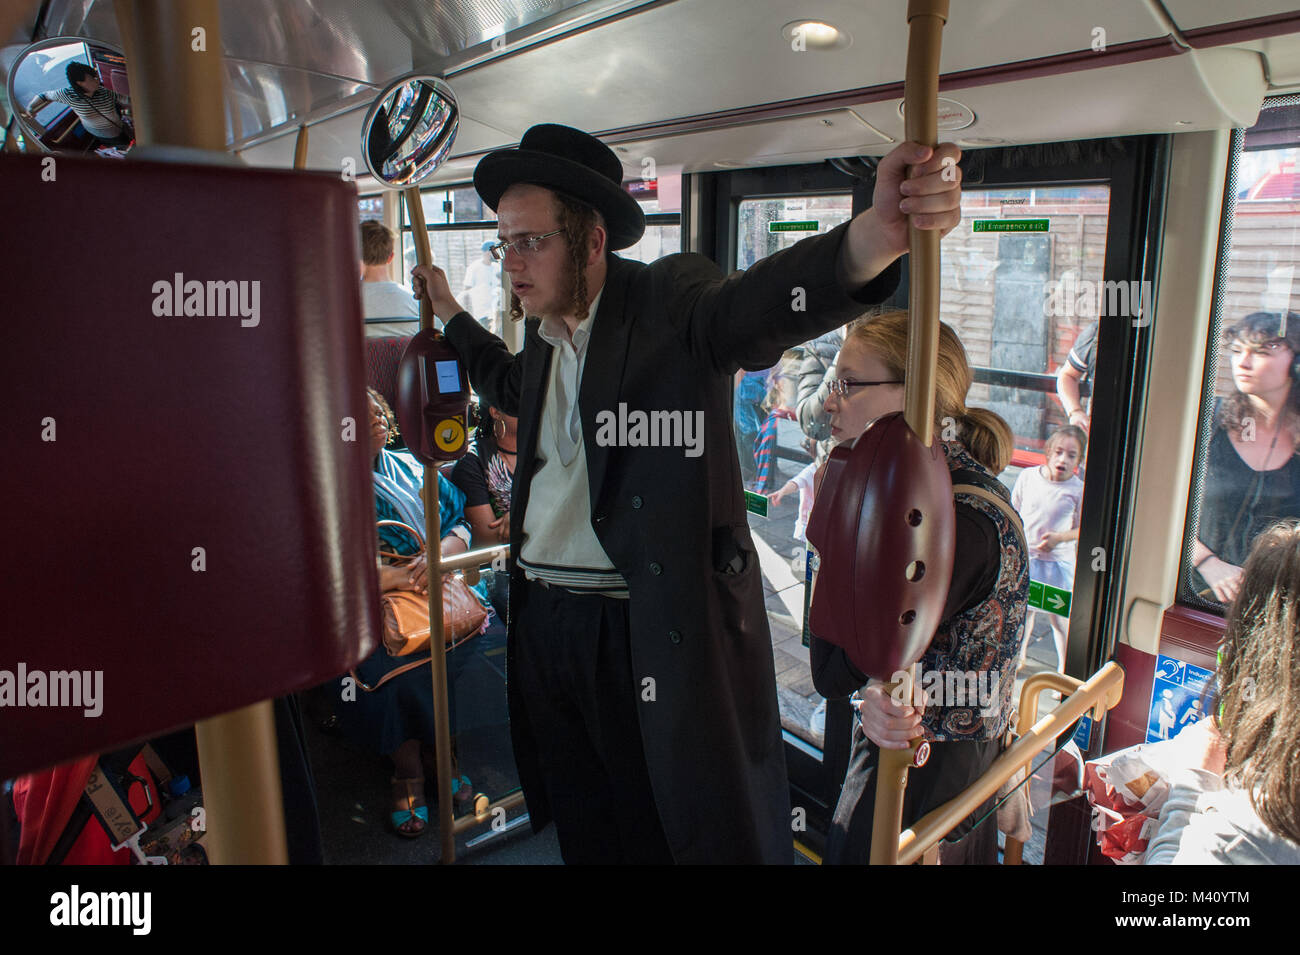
[1191,312,1300,603]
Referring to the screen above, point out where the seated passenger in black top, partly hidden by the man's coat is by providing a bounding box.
[451,405,519,620]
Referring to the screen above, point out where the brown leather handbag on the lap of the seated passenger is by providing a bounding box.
[352,521,488,693]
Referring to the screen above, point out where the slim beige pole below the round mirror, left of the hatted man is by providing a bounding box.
[402,186,456,865]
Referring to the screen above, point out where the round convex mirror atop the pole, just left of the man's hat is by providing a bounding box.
[361,75,460,188]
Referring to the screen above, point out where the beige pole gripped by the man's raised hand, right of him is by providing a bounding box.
[871,0,948,865]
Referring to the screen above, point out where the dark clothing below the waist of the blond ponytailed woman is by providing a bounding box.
[826,725,1002,865]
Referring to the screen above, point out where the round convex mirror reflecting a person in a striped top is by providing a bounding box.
[8,36,135,157]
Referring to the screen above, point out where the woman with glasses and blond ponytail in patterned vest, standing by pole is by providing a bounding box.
[811,311,1030,864]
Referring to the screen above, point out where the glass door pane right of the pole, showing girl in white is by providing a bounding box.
[940,185,1112,676]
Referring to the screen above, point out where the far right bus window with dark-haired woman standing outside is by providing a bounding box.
[1179,97,1300,612]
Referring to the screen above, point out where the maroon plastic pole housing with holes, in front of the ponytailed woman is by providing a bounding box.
[807,413,956,680]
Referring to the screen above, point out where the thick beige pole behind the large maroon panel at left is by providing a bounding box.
[114,0,289,865]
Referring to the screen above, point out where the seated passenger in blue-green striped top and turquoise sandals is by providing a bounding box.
[335,388,483,838]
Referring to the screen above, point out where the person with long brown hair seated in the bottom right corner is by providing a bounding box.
[1144,521,1300,865]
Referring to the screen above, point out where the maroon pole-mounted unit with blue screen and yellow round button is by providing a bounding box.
[397,329,476,464]
